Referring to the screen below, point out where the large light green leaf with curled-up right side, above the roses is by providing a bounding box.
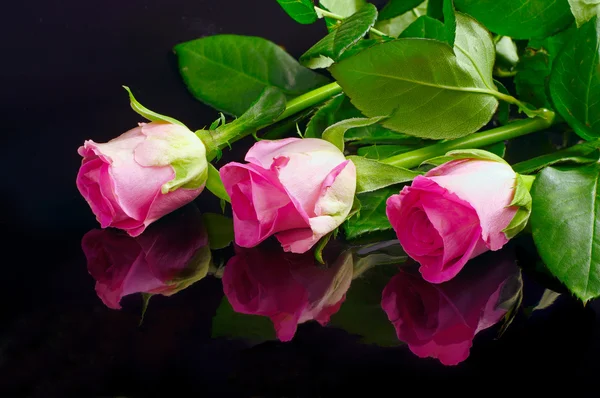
[330,14,498,139]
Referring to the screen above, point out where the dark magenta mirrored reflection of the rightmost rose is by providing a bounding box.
[381,252,523,365]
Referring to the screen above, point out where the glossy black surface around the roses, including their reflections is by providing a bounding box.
[0,0,600,397]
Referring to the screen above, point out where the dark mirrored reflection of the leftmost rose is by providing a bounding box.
[81,204,211,309]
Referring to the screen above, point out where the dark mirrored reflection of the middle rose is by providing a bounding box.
[223,247,353,341]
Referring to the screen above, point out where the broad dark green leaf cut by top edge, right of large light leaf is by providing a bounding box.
[454,0,573,39]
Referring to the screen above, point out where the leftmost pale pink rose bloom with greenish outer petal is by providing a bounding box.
[77,122,208,236]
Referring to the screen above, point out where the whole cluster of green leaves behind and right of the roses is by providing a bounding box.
[175,0,600,301]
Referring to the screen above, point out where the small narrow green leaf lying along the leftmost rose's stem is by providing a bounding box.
[216,87,286,139]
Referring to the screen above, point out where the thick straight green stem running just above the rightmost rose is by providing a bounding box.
[381,110,554,169]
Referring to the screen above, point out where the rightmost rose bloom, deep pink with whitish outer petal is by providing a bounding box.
[386,159,518,283]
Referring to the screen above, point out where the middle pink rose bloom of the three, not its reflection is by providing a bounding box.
[220,138,356,253]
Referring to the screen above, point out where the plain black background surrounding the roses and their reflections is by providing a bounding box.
[0,0,600,396]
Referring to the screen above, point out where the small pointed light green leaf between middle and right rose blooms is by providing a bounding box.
[348,156,421,193]
